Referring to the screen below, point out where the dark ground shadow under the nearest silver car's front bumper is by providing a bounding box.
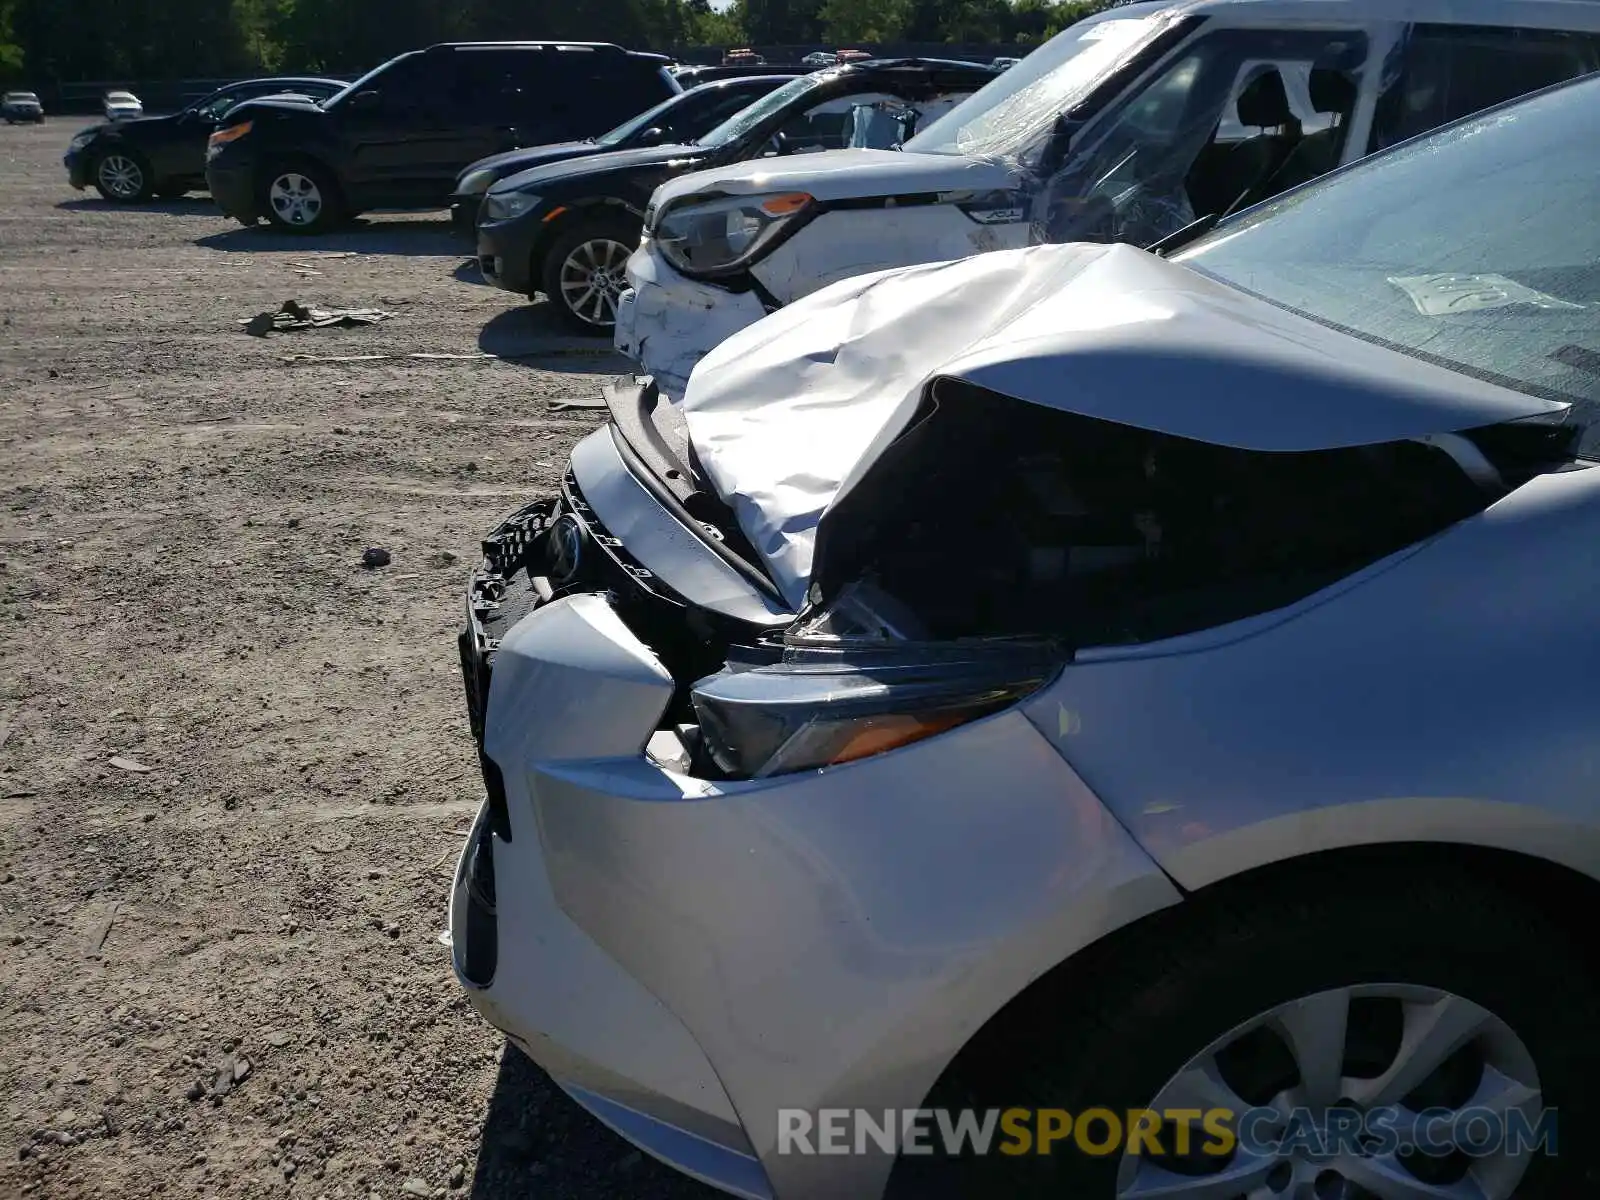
[470,1043,723,1200]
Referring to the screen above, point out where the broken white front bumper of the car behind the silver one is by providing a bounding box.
[614,238,766,400]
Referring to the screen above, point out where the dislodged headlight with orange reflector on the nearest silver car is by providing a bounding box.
[691,643,1061,779]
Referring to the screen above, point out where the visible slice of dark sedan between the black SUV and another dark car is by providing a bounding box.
[450,75,795,237]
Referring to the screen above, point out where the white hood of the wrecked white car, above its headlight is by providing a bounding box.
[653,150,1016,210]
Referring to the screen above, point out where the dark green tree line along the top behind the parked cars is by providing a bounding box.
[0,0,1112,85]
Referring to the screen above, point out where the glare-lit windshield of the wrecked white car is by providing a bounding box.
[906,13,1171,157]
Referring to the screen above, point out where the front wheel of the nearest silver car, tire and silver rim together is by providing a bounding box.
[888,858,1600,1200]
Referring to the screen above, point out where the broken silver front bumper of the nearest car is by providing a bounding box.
[450,454,1176,1200]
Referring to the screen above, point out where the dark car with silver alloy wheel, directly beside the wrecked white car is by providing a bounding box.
[478,59,995,334]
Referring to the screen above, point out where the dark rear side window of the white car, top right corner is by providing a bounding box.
[1370,24,1600,150]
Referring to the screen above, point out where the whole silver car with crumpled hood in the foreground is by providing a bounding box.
[450,78,1600,1200]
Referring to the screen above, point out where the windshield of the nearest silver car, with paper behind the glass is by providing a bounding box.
[1173,80,1600,454]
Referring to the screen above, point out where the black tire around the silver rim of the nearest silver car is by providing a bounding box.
[886,858,1600,1200]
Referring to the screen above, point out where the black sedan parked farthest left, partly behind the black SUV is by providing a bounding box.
[64,75,346,205]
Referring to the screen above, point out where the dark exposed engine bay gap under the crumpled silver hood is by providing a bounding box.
[814,379,1565,648]
